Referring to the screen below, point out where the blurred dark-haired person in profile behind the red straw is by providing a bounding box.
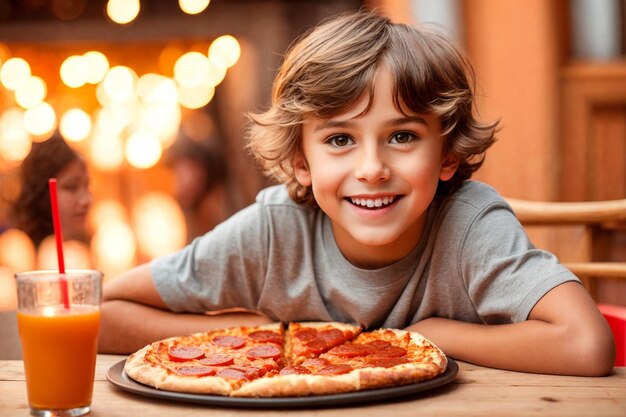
[11,134,93,247]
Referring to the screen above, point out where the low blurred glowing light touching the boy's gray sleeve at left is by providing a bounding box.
[132,192,187,258]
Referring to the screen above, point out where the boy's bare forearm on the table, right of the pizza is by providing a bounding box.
[408,318,614,376]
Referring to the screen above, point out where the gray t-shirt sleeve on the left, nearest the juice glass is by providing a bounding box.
[151,203,268,313]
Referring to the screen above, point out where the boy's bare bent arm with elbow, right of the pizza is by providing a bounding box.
[408,282,615,376]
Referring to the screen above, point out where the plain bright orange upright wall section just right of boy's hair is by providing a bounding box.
[465,0,560,200]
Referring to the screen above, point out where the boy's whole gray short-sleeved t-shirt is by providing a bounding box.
[151,181,577,328]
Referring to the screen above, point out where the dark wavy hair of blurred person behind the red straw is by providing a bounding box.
[11,134,82,246]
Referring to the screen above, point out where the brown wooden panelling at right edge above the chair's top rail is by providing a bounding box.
[559,60,626,201]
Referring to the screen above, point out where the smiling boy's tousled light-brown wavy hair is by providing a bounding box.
[247,11,498,205]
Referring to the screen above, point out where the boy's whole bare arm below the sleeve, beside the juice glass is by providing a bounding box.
[99,264,270,353]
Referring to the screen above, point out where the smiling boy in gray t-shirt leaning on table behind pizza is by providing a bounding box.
[101,13,615,375]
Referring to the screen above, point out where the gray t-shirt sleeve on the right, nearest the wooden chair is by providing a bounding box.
[458,201,579,324]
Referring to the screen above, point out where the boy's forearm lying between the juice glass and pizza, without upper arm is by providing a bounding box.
[98,300,270,354]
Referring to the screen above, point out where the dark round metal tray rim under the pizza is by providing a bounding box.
[106,358,459,408]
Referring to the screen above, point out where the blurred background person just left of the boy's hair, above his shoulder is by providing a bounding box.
[166,130,232,241]
